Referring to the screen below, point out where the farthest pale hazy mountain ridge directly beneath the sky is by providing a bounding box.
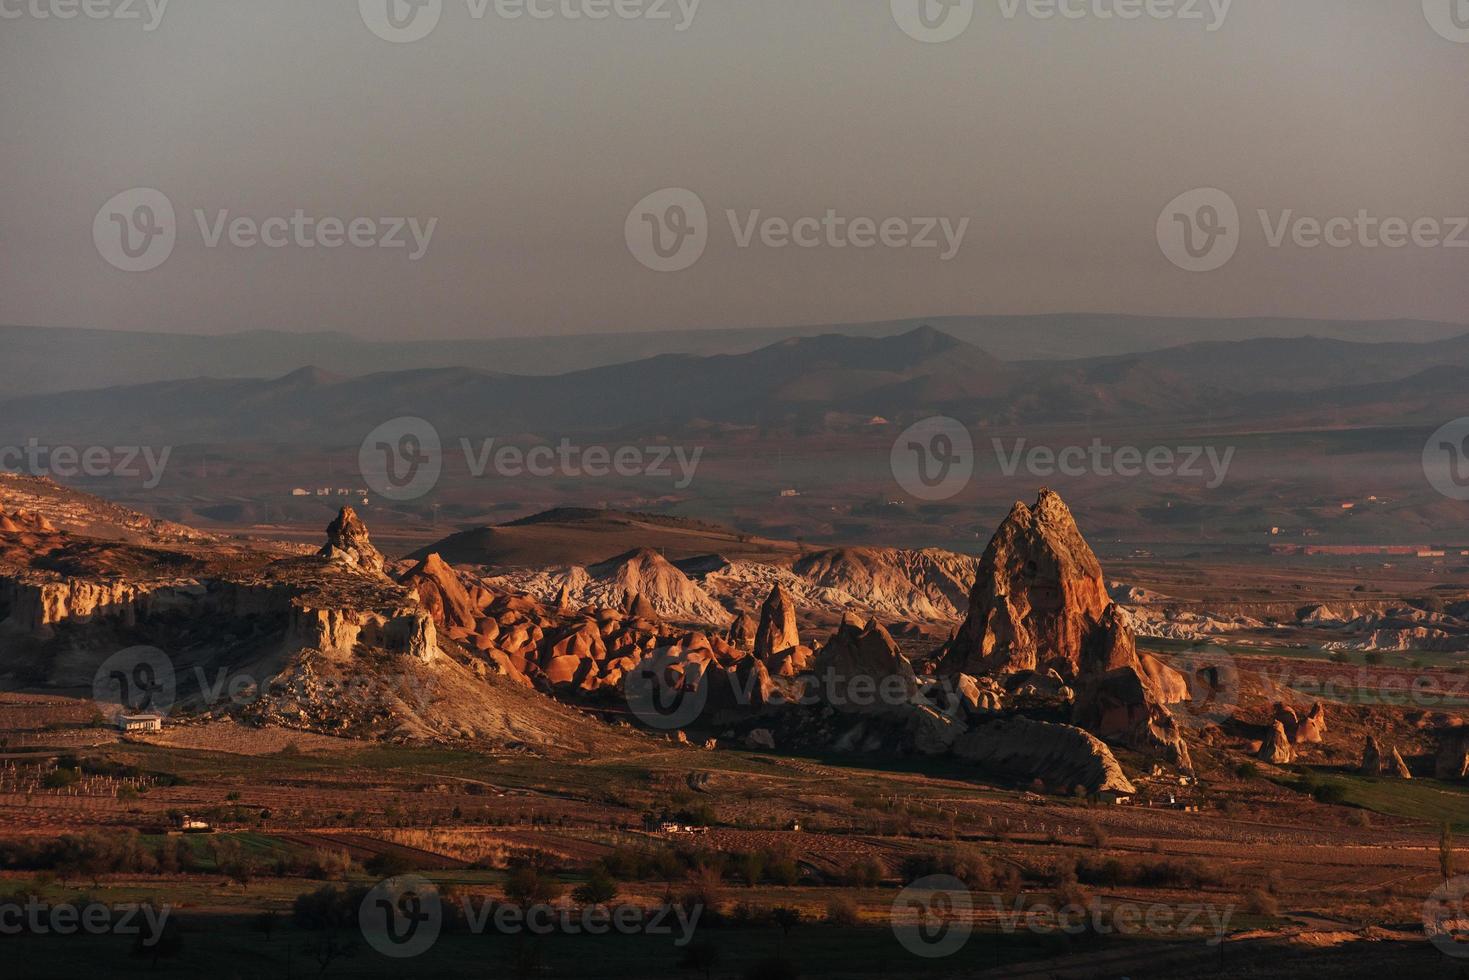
[0,314,1469,397]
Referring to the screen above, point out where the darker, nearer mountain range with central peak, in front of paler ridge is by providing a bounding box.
[0,326,1469,445]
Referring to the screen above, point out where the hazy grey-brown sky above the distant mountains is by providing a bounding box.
[0,0,1469,338]
